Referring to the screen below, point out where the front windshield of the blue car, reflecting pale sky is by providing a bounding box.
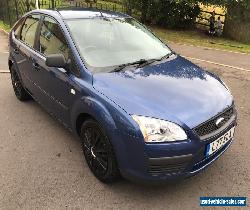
[66,18,171,72]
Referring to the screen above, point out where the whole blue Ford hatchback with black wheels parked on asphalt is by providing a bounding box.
[9,9,236,183]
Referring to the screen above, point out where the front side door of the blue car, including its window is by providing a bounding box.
[32,16,78,125]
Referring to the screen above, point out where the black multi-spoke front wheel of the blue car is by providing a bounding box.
[81,119,120,183]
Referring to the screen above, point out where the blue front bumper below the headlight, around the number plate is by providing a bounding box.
[117,122,236,183]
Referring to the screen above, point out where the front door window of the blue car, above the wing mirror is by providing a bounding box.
[39,16,70,60]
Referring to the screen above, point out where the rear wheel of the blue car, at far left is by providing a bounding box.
[10,66,31,101]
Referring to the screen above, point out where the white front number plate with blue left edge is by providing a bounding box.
[206,127,235,156]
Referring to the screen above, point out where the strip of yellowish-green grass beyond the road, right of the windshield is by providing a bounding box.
[150,27,250,54]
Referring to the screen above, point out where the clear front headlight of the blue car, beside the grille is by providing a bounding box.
[132,115,187,143]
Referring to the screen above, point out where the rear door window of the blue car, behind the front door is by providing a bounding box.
[20,15,40,47]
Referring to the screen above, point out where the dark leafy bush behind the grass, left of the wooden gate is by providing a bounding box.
[125,0,200,28]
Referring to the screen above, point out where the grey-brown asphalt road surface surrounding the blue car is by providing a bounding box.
[0,30,250,210]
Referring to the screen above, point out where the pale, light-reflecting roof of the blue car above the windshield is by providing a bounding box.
[30,7,130,19]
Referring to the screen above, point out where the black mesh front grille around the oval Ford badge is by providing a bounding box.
[193,107,234,137]
